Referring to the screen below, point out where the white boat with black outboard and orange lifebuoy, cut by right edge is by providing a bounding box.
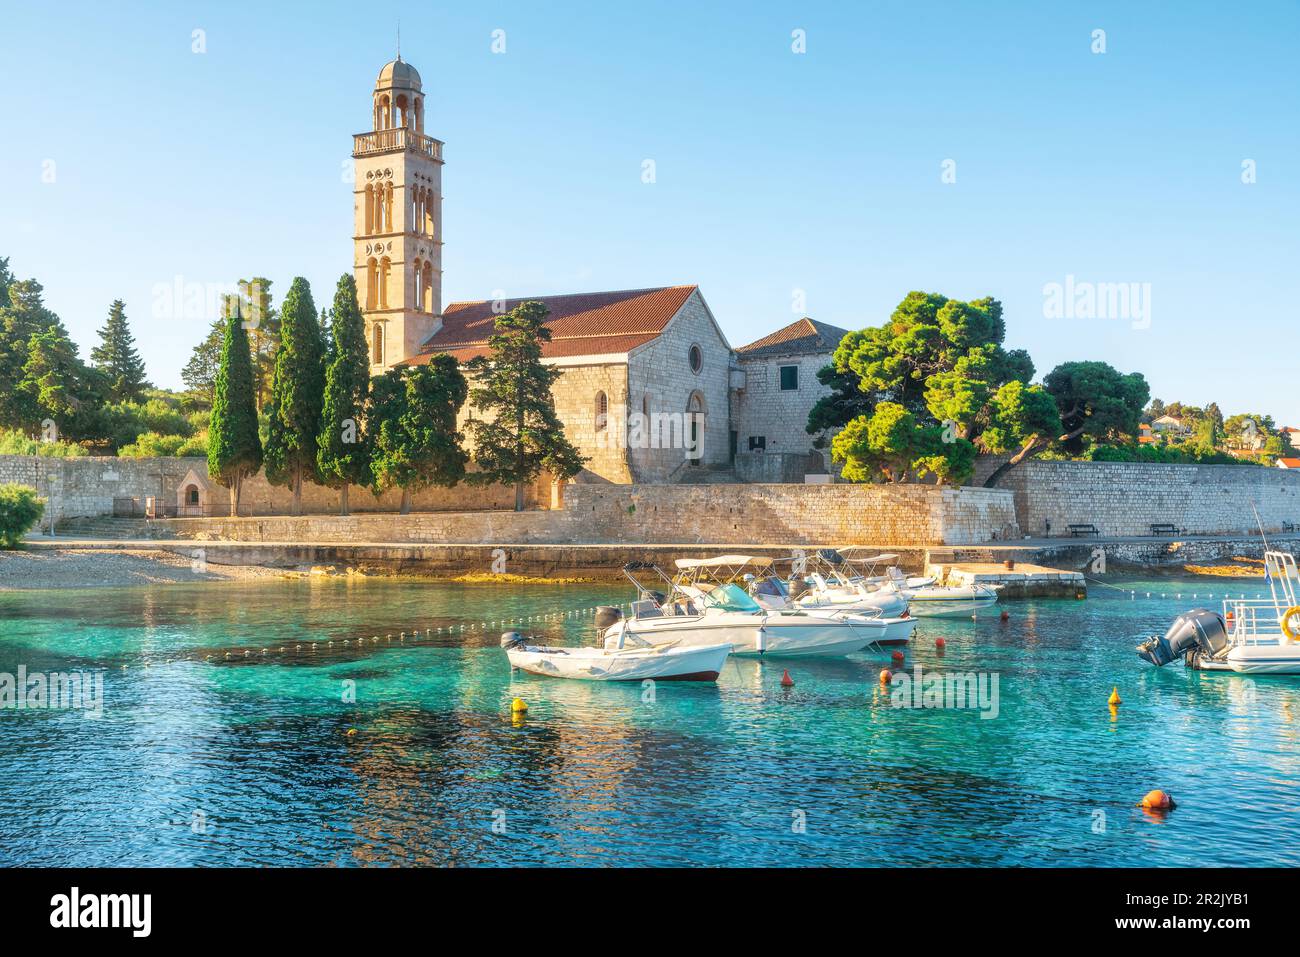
[1138,551,1300,675]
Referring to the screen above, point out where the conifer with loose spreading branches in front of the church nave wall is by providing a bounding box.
[465,302,586,511]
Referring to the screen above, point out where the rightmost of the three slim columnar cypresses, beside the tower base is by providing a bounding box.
[316,273,371,515]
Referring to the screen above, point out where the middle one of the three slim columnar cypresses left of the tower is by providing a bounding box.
[265,276,325,515]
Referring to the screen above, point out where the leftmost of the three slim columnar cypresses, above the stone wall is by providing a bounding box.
[208,296,261,516]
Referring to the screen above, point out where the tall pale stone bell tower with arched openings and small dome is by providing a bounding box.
[352,55,442,376]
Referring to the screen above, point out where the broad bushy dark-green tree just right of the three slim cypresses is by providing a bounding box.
[369,356,469,515]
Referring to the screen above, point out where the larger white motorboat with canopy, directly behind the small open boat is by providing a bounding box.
[597,555,883,658]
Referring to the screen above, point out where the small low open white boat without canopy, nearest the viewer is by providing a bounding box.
[501,632,731,681]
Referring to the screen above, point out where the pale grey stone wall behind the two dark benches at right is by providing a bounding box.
[976,460,1300,536]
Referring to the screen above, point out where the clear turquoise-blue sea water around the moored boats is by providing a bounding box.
[0,579,1300,866]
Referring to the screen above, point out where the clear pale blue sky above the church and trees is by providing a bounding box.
[0,0,1300,425]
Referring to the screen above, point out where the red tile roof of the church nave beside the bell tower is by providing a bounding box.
[402,286,698,365]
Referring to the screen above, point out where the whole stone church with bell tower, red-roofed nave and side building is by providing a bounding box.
[352,56,845,484]
